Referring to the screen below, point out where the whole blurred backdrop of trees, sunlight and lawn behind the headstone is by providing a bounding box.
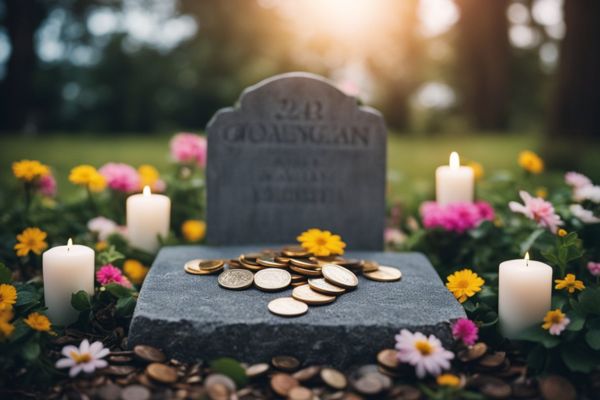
[0,0,600,200]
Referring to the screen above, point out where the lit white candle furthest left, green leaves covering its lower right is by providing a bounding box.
[42,239,95,325]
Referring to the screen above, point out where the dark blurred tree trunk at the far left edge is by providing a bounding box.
[0,0,46,131]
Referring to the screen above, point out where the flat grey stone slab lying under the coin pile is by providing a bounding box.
[129,246,465,367]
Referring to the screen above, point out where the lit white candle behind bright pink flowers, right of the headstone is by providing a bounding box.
[435,152,474,205]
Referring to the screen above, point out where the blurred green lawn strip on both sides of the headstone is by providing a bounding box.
[0,133,600,206]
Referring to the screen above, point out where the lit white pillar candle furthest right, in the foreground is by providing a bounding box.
[498,253,552,337]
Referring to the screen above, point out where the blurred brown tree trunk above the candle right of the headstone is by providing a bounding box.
[456,0,510,130]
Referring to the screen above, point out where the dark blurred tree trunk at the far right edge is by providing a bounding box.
[548,0,600,139]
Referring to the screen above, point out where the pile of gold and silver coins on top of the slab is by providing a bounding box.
[184,246,402,317]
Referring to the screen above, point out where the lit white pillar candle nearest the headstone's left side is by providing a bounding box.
[127,186,171,253]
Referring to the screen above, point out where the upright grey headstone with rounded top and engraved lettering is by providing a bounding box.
[206,73,387,250]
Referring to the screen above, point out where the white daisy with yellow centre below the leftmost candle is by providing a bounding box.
[56,339,110,377]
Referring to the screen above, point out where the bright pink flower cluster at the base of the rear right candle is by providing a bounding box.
[420,201,494,233]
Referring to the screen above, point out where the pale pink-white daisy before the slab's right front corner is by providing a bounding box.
[396,329,454,378]
